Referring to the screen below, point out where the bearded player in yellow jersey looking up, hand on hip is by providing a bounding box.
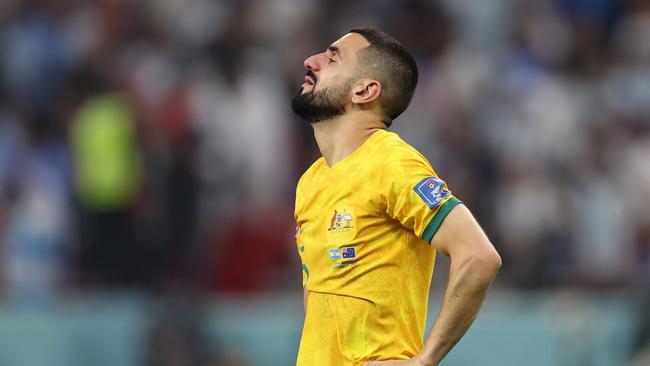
[292,29,501,366]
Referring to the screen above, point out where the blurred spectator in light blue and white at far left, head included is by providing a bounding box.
[0,107,72,306]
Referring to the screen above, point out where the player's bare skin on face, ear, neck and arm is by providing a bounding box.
[300,33,501,366]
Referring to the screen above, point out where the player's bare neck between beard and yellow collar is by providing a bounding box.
[312,112,385,167]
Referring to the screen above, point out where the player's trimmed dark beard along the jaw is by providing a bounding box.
[291,78,350,123]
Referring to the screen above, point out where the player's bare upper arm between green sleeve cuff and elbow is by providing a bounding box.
[431,204,496,257]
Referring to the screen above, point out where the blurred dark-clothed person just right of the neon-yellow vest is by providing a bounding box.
[138,89,201,288]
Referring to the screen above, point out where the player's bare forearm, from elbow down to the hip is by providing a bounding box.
[420,253,501,365]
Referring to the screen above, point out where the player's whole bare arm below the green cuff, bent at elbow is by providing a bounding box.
[419,205,501,365]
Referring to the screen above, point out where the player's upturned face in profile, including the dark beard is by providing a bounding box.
[291,33,370,123]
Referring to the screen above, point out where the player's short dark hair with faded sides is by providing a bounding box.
[350,28,418,127]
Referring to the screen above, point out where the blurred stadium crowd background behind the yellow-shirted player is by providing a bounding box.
[0,0,650,366]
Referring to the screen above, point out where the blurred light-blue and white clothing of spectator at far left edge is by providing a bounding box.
[0,136,70,307]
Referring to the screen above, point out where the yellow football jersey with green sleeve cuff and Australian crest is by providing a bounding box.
[295,130,460,366]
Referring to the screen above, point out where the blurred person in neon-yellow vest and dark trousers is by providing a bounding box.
[69,62,143,287]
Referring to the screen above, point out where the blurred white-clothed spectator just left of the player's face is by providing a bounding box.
[190,46,293,217]
